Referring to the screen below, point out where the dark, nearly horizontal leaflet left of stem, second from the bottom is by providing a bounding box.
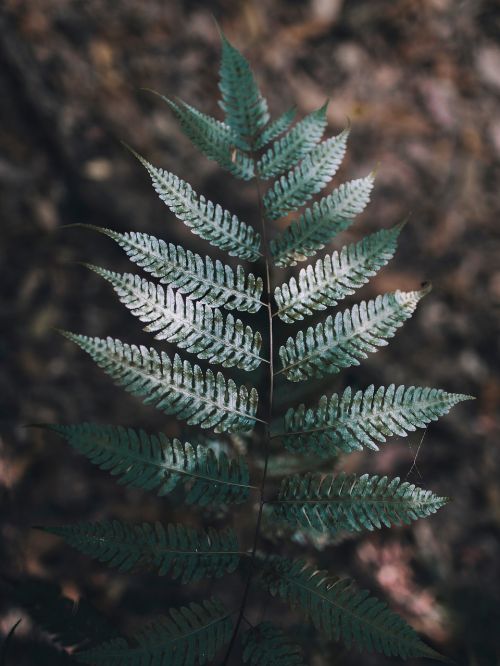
[42,520,240,584]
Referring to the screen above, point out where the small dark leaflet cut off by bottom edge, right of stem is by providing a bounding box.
[242,622,304,666]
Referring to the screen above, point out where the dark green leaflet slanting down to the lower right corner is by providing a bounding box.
[262,556,441,660]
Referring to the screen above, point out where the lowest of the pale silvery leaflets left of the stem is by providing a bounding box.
[62,331,258,432]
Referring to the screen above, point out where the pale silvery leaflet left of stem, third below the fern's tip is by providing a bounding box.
[78,225,263,312]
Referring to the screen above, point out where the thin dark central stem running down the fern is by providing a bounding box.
[222,158,274,666]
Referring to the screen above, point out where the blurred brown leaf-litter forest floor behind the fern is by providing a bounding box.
[0,0,500,666]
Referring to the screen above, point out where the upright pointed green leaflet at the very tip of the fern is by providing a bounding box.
[219,35,269,140]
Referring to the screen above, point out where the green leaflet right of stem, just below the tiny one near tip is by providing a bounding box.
[257,104,328,178]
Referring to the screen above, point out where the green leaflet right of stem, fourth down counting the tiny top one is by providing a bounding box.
[269,174,374,266]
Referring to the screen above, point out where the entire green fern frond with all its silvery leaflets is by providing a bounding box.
[36,31,468,666]
